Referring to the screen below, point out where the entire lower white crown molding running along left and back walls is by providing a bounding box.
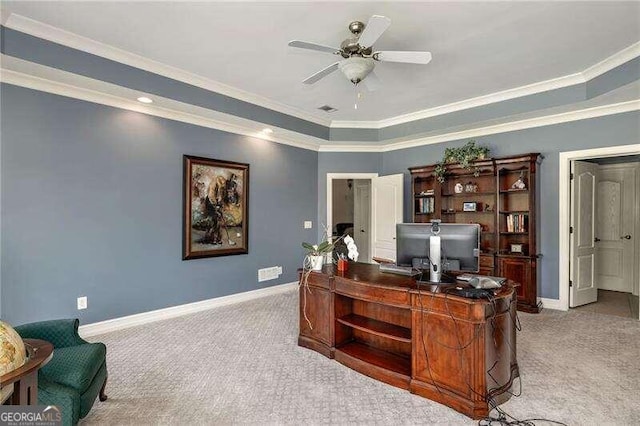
[0,55,640,152]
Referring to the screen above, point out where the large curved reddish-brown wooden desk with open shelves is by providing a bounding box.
[298,263,519,419]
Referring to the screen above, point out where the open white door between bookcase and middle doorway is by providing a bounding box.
[371,174,404,262]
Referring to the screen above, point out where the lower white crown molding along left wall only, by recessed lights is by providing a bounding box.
[0,65,319,151]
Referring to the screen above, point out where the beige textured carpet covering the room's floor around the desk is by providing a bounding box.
[84,292,640,425]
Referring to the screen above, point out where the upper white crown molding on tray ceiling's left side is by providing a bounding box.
[4,13,331,126]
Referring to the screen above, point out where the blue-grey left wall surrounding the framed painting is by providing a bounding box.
[0,84,318,324]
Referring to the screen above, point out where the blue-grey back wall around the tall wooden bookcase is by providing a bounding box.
[381,112,640,299]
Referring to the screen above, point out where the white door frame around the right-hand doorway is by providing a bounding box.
[556,144,640,311]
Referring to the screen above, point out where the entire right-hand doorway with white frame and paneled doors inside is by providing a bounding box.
[558,145,640,319]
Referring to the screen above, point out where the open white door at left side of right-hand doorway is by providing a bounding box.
[569,161,598,308]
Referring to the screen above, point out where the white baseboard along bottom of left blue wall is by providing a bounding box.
[79,281,298,337]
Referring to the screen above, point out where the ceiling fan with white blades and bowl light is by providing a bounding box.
[289,15,431,90]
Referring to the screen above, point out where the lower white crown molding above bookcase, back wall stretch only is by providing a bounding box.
[319,99,640,152]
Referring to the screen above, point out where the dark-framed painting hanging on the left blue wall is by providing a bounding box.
[182,155,249,260]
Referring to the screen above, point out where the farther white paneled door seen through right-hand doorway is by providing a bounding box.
[596,164,636,293]
